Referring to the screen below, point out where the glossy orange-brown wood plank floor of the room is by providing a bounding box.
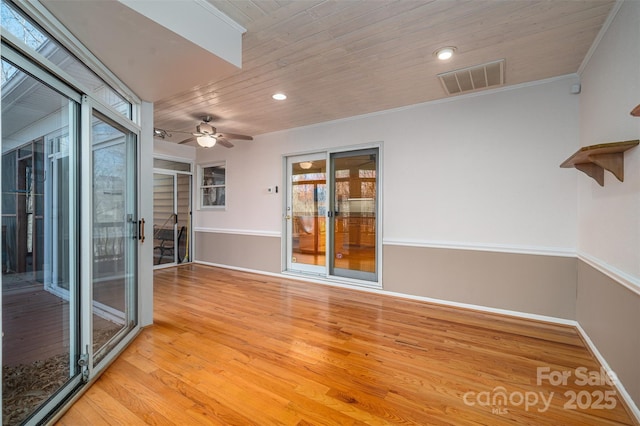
[59,265,636,425]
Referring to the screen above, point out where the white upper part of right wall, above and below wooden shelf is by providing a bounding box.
[578,1,640,283]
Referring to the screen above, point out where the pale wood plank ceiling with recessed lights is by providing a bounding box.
[155,0,615,141]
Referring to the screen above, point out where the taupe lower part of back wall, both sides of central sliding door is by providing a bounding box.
[195,232,577,320]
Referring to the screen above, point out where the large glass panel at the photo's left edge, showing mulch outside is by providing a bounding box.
[1,60,81,424]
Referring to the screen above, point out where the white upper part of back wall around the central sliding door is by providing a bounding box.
[194,77,579,252]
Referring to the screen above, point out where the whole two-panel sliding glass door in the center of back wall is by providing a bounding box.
[284,148,379,285]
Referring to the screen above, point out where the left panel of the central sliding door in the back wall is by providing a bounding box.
[286,155,327,274]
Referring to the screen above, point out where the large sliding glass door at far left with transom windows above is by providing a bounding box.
[0,2,144,425]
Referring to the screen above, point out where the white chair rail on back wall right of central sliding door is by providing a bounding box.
[383,238,576,257]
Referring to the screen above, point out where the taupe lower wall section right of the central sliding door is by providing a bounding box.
[383,245,576,319]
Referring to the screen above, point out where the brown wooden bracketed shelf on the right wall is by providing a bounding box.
[560,140,640,186]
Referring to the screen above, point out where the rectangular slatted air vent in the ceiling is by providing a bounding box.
[438,59,504,95]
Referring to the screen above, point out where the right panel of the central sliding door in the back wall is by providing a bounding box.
[330,149,378,281]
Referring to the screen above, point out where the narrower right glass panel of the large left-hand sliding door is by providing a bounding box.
[91,113,137,364]
